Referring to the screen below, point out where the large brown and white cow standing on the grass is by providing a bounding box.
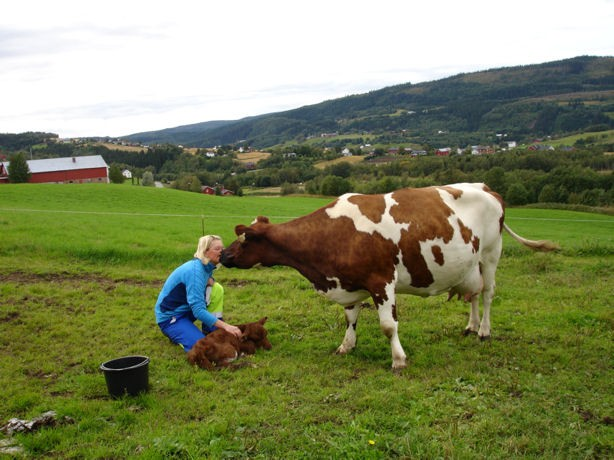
[220,183,558,370]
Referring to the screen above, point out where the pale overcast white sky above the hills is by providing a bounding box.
[0,0,614,138]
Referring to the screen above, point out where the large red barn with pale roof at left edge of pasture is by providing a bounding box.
[0,155,109,184]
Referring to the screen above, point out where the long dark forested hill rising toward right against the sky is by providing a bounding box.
[126,56,614,148]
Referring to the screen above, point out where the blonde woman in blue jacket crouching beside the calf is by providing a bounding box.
[155,235,241,352]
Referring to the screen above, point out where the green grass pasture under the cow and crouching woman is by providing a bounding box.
[0,184,614,459]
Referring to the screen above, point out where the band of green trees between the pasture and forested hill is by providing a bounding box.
[4,135,614,207]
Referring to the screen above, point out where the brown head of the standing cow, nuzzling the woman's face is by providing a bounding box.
[220,216,271,268]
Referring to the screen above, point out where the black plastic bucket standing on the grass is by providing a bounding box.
[100,356,149,397]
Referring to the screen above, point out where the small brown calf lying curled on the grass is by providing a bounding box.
[187,317,272,370]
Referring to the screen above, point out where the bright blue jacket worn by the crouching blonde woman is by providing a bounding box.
[155,258,217,327]
